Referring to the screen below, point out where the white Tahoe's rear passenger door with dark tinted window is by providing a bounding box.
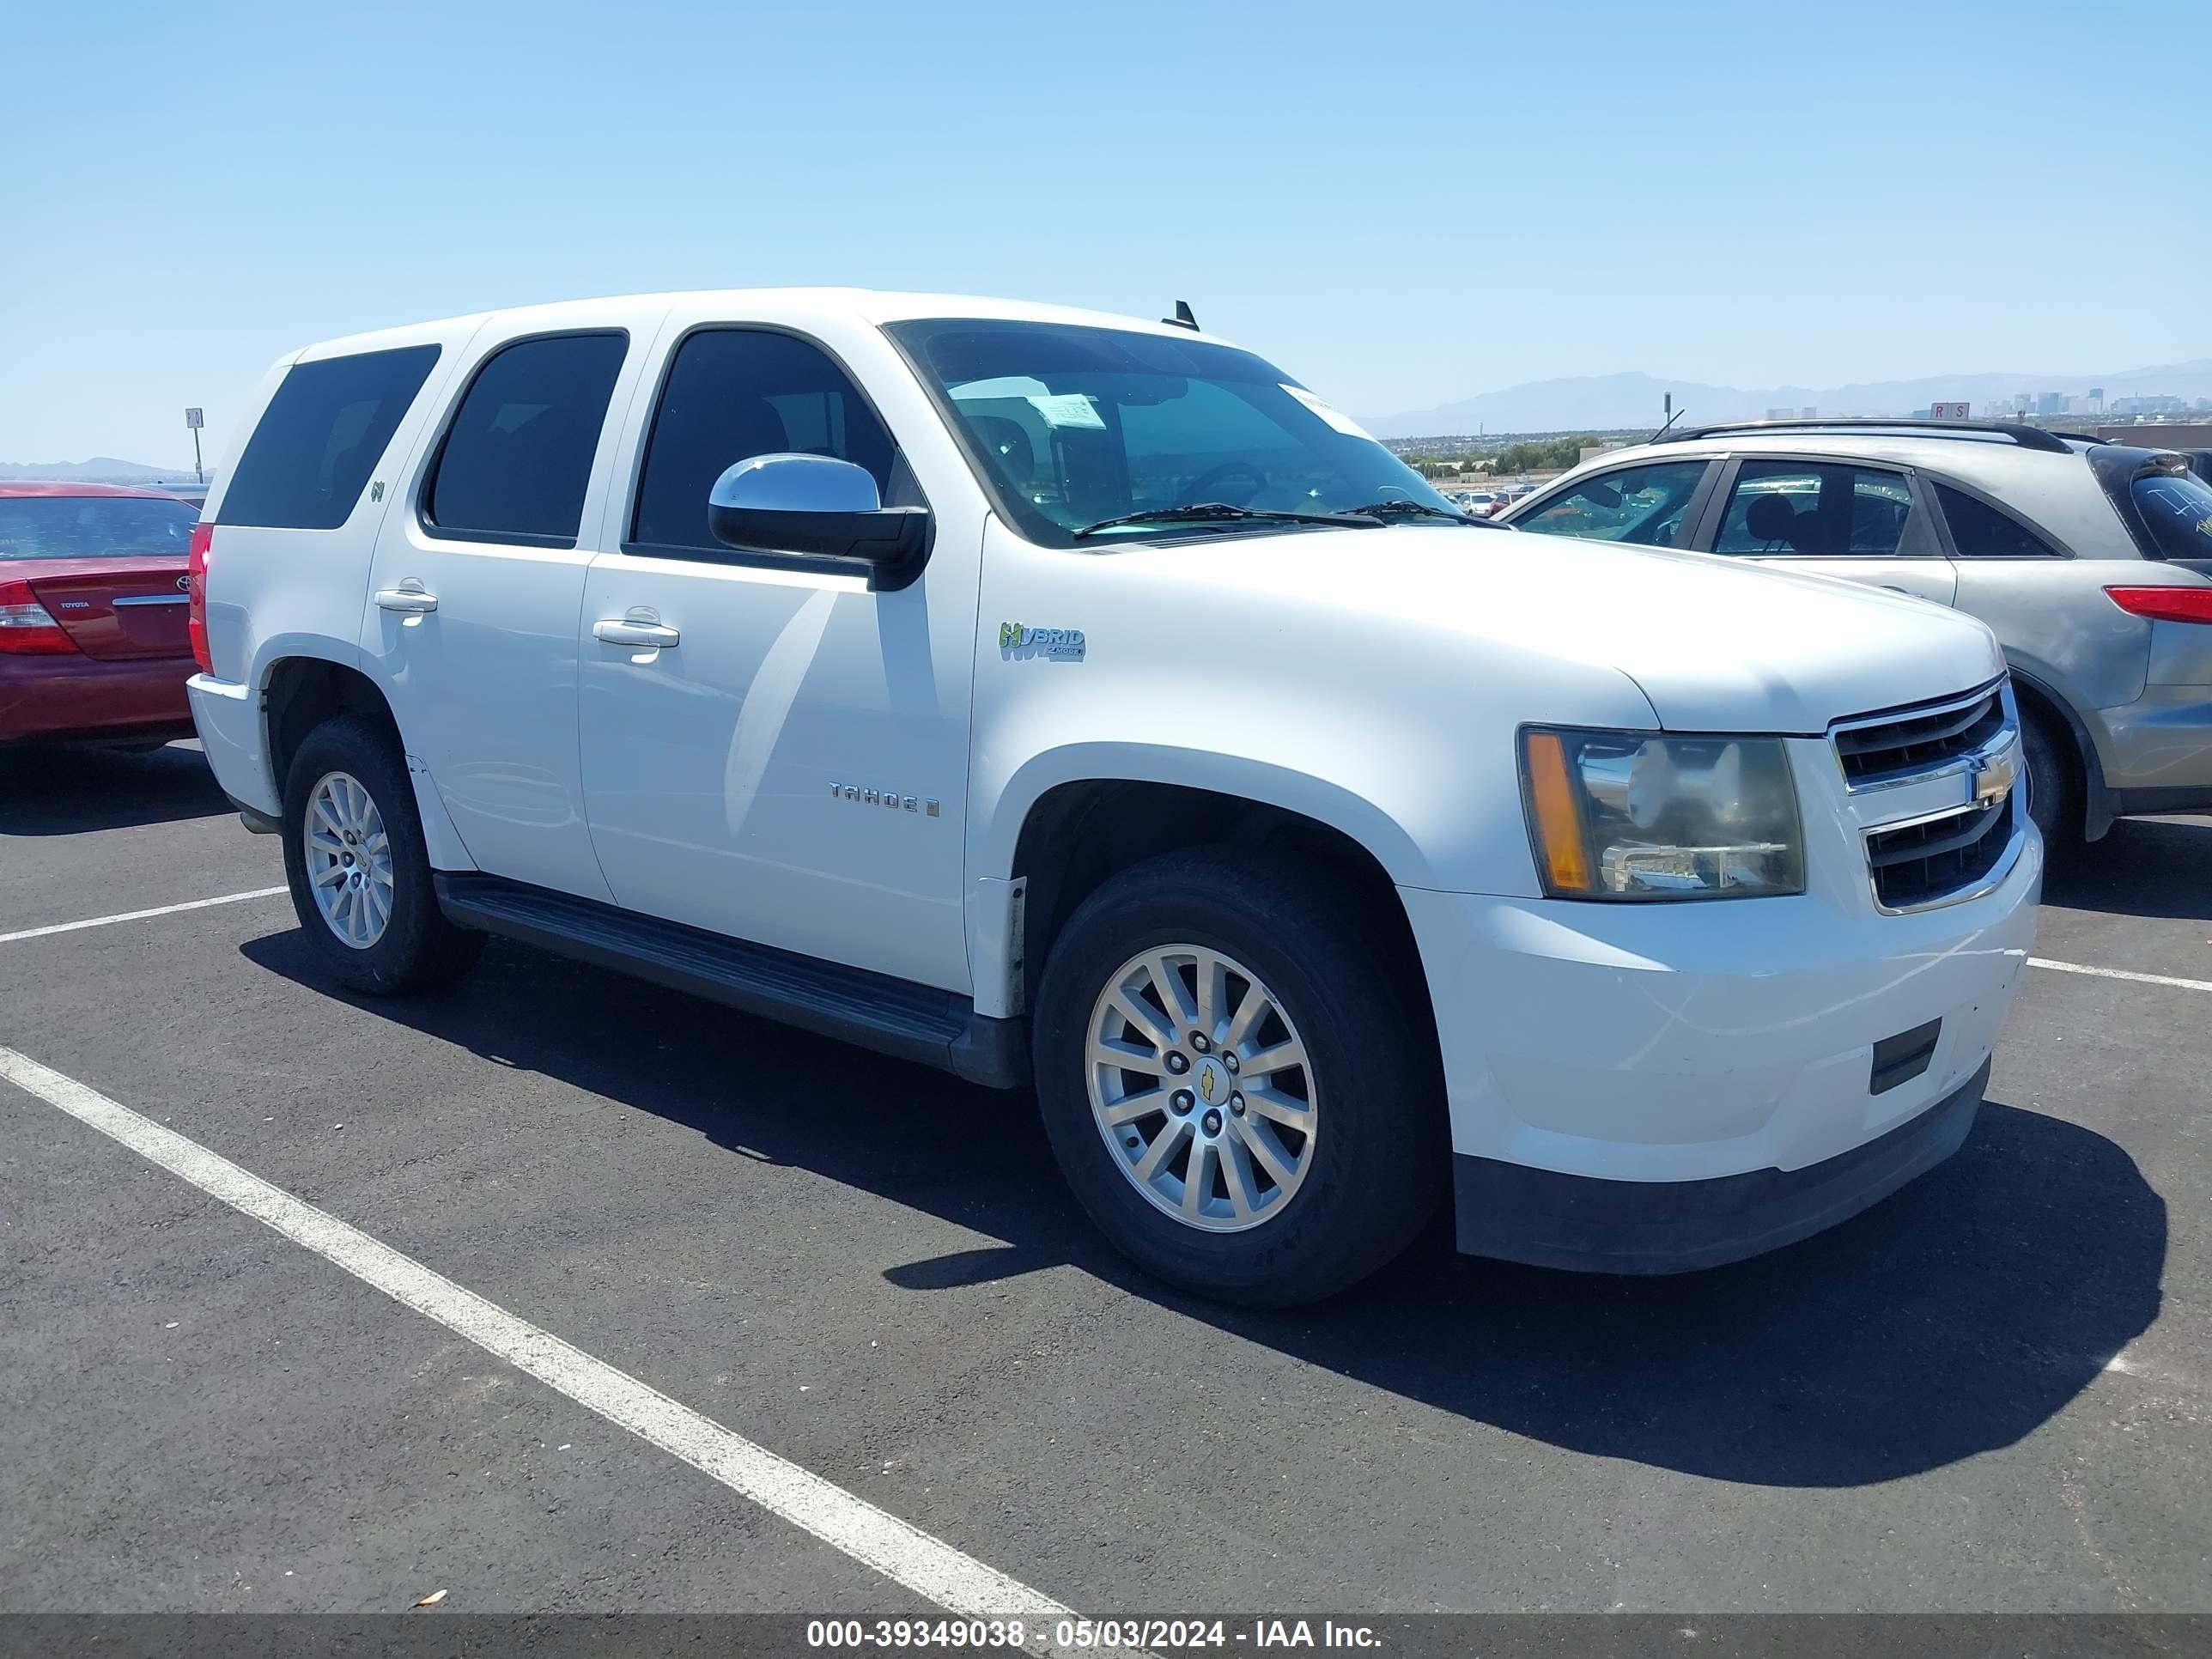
[361,305,665,900]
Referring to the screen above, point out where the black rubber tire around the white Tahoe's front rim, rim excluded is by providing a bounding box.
[1033,854,1449,1307]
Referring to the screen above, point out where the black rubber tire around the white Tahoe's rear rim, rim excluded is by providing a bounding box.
[283,714,483,995]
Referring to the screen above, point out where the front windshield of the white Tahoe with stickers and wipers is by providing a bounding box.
[887,321,1460,546]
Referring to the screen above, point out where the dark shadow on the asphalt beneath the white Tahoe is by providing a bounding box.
[241,931,2166,1486]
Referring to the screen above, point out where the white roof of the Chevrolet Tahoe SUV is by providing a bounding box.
[283,288,1232,361]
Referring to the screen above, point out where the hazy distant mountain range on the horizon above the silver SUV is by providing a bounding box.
[1360,356,2212,438]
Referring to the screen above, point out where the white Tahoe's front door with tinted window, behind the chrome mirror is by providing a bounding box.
[580,327,978,994]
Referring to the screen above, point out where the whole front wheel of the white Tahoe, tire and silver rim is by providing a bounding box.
[1036,848,1449,1307]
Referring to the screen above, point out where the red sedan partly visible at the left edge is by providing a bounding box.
[0,484,199,745]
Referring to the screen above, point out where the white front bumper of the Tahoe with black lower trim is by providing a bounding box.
[1401,832,2042,1272]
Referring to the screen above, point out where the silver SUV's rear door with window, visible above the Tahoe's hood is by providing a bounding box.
[1697,456,1958,604]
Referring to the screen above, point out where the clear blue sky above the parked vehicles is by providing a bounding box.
[0,0,2212,465]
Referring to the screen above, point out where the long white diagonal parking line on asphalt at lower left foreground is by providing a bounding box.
[0,1043,1073,1646]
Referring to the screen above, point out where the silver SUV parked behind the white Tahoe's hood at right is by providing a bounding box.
[1502,420,2212,842]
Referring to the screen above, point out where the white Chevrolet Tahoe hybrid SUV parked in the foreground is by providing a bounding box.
[191,289,2042,1303]
